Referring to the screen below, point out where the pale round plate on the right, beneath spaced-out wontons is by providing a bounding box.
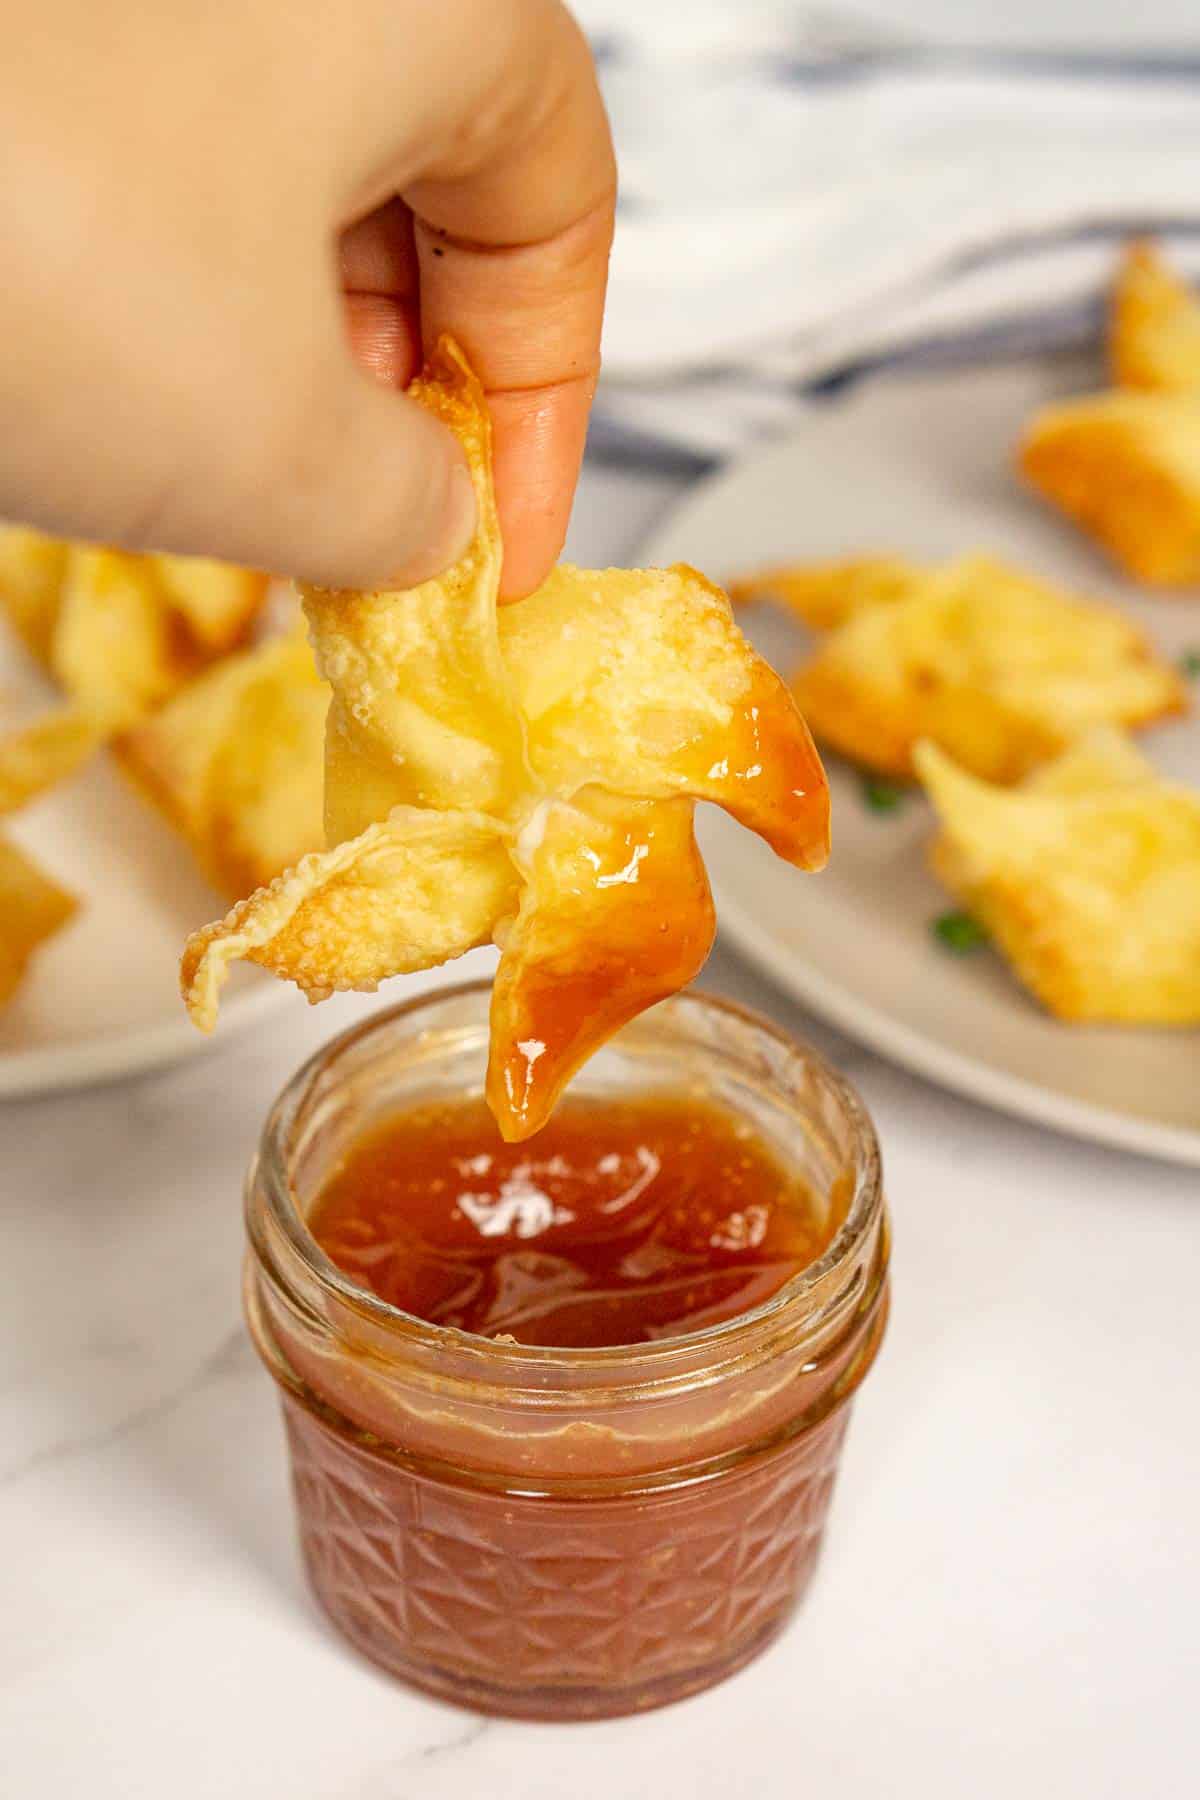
[644,364,1200,1165]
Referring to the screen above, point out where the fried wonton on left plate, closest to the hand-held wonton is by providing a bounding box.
[117,628,329,900]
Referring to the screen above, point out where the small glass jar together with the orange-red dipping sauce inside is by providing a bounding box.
[246,985,889,1719]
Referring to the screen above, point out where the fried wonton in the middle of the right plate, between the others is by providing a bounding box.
[793,556,1187,781]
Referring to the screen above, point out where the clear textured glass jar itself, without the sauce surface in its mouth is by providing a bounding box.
[246,985,887,1719]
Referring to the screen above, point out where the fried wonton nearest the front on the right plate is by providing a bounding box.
[916,731,1200,1024]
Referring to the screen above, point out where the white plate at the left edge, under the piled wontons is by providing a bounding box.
[0,655,288,1096]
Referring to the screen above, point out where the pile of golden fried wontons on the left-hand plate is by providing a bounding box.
[0,526,327,1004]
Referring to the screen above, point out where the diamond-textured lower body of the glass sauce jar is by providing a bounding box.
[282,1395,847,1719]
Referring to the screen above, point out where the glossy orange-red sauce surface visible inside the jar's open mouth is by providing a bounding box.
[308,1096,837,1348]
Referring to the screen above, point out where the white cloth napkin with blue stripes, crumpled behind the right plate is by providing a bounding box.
[581,0,1200,459]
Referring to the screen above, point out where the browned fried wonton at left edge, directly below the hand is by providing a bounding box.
[0,526,266,812]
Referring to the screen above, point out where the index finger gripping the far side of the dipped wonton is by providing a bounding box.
[405,7,615,599]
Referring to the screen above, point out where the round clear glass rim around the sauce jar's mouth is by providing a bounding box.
[248,979,883,1375]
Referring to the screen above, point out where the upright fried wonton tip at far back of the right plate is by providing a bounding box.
[1108,243,1200,394]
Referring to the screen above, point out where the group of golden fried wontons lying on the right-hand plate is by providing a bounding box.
[730,245,1200,1024]
